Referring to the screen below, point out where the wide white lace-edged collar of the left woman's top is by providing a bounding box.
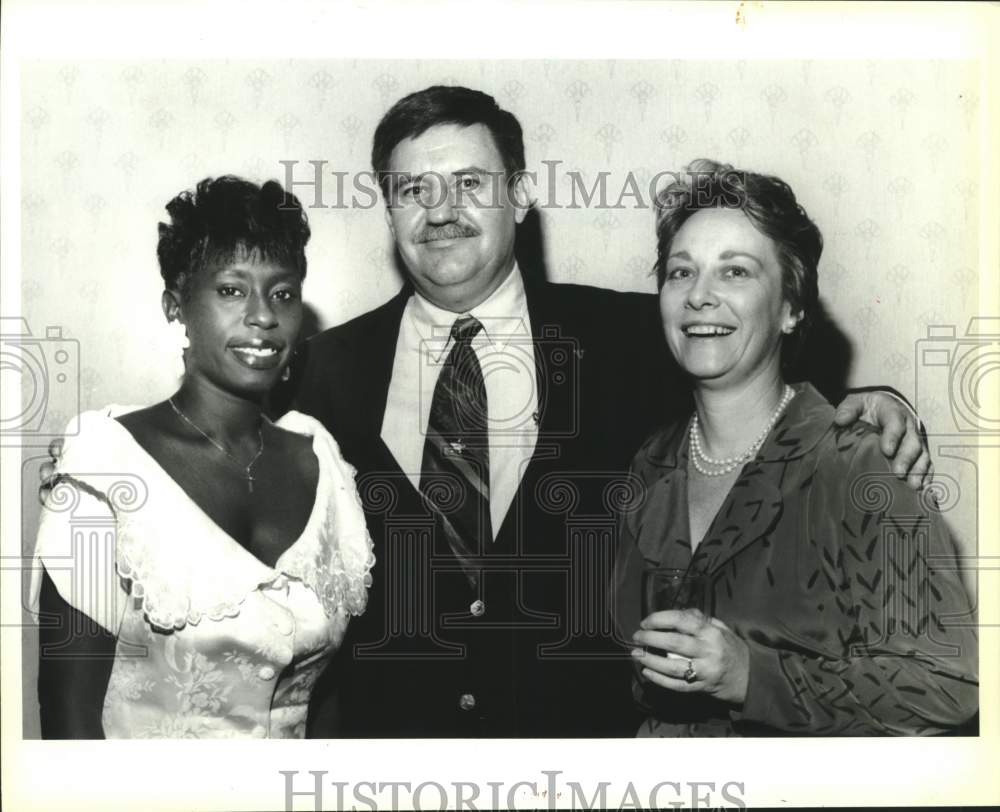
[50,406,374,630]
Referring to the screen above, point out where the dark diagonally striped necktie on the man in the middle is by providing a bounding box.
[420,316,493,583]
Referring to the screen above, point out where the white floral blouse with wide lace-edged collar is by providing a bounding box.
[32,407,374,738]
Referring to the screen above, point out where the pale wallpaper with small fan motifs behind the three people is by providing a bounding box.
[15,55,980,728]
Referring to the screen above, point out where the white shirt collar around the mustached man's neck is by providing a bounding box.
[410,263,531,361]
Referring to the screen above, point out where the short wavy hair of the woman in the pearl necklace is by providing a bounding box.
[654,158,823,350]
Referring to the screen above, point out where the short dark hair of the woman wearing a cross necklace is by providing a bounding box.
[156,175,310,293]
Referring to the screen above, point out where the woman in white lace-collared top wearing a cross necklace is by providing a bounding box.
[33,176,373,738]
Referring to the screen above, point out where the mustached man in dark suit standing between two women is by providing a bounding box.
[291,87,926,737]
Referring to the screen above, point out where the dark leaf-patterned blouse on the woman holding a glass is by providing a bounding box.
[613,384,978,736]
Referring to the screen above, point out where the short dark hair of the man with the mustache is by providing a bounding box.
[372,85,524,194]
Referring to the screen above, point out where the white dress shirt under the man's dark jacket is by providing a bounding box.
[382,266,538,538]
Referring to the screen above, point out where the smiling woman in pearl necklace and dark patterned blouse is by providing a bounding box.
[614,161,978,736]
